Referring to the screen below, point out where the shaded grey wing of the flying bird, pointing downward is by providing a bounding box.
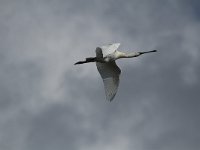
[96,61,121,101]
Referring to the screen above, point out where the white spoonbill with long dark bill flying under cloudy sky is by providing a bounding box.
[74,43,157,102]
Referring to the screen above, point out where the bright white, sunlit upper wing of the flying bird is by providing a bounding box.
[101,43,120,57]
